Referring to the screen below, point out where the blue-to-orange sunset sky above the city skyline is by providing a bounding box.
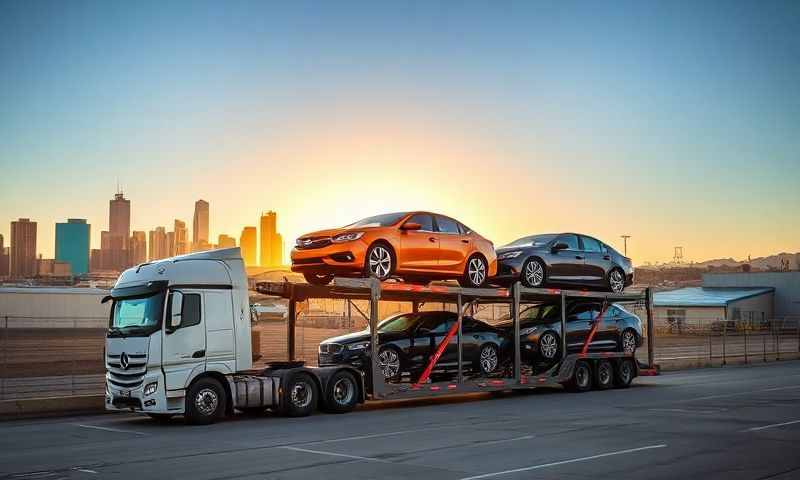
[0,0,800,264]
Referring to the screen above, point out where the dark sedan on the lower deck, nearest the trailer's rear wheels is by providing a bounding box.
[498,301,643,363]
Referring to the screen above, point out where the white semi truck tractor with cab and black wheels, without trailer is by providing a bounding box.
[104,248,364,424]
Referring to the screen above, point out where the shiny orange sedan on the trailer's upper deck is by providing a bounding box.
[292,212,497,287]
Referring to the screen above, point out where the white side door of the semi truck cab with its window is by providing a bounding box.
[161,290,206,390]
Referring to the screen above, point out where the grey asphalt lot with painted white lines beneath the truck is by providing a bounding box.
[0,362,800,480]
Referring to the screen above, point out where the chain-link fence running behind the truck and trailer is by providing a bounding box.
[0,308,800,400]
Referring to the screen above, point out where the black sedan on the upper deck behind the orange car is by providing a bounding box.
[494,233,633,293]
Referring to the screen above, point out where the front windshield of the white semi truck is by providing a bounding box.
[109,292,164,336]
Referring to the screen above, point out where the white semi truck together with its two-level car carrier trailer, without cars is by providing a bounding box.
[103,248,653,424]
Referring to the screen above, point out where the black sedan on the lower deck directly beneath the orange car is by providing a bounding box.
[319,311,504,381]
